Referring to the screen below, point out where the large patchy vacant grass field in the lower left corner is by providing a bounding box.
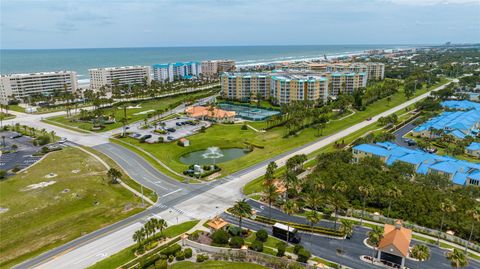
[0,148,142,268]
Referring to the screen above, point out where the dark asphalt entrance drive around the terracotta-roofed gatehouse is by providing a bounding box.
[222,200,480,269]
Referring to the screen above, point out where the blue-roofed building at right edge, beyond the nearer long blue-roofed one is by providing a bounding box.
[412,110,480,140]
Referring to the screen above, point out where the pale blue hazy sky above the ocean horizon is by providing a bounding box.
[0,0,480,49]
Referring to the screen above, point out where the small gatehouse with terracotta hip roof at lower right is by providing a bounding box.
[377,220,412,268]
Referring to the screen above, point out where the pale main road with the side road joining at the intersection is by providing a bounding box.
[7,78,458,268]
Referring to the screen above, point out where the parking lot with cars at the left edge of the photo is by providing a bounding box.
[0,132,41,171]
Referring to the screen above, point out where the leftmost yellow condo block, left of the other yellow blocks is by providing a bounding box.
[220,73,271,101]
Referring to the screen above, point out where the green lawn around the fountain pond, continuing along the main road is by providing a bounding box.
[114,81,445,180]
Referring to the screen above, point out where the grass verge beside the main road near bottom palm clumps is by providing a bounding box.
[88,220,198,269]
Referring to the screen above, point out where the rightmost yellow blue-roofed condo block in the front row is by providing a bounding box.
[325,72,368,96]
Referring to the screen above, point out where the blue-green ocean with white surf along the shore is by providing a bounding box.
[0,45,413,82]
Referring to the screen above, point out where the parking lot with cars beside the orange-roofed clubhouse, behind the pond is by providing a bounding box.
[129,117,210,143]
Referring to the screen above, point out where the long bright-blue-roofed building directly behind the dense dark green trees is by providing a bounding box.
[352,142,480,186]
